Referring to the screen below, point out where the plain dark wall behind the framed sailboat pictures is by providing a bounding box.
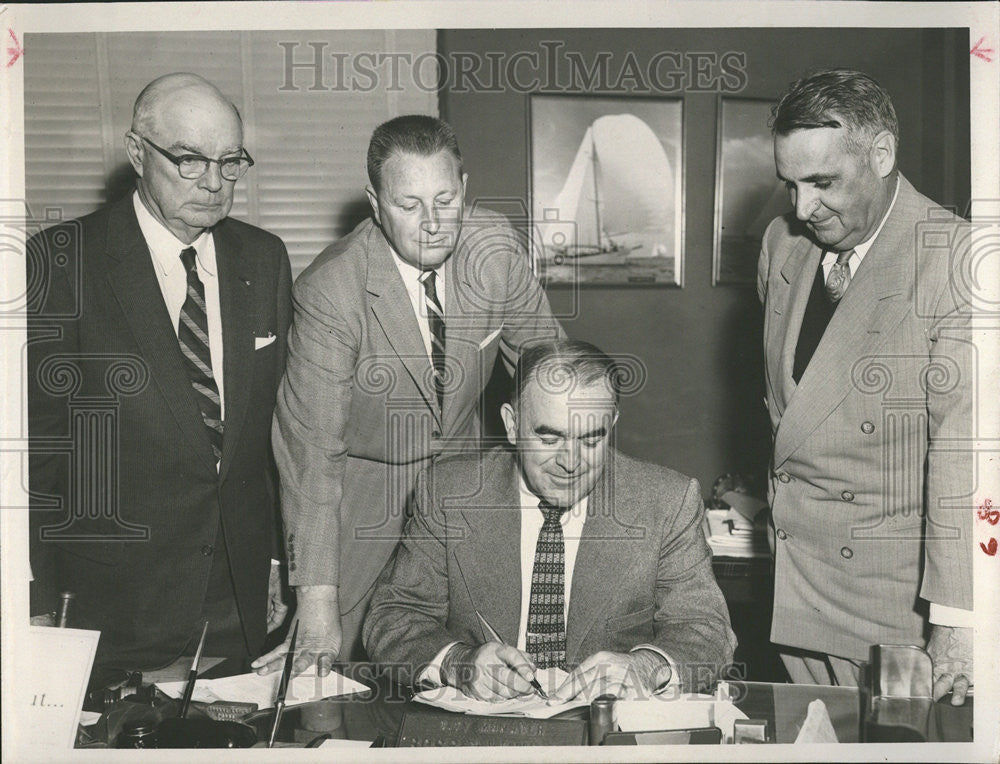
[438,29,970,495]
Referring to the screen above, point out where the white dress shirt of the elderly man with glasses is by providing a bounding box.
[132,191,226,421]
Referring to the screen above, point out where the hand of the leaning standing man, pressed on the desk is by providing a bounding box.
[250,586,343,676]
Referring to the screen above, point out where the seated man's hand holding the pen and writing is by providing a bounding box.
[441,642,535,702]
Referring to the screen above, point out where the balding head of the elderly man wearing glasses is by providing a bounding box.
[125,73,243,243]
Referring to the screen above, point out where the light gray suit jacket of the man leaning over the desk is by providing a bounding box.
[273,210,563,613]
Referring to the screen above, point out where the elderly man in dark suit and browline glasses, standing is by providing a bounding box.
[28,74,291,681]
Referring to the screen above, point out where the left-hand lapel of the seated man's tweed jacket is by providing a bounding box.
[455,449,521,645]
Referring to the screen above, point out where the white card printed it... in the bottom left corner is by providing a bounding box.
[18,626,101,748]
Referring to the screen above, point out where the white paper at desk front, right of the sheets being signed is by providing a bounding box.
[615,693,747,740]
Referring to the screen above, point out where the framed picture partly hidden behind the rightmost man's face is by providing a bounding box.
[712,96,792,286]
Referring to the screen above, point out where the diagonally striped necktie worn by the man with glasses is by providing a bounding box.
[177,247,223,461]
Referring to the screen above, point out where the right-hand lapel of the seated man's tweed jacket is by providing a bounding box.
[566,462,645,665]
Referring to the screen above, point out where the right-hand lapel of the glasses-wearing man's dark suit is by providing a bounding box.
[213,222,256,480]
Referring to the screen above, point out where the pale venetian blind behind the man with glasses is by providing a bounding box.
[24,30,437,275]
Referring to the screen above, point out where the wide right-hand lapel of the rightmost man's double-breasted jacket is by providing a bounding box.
[774,176,914,467]
